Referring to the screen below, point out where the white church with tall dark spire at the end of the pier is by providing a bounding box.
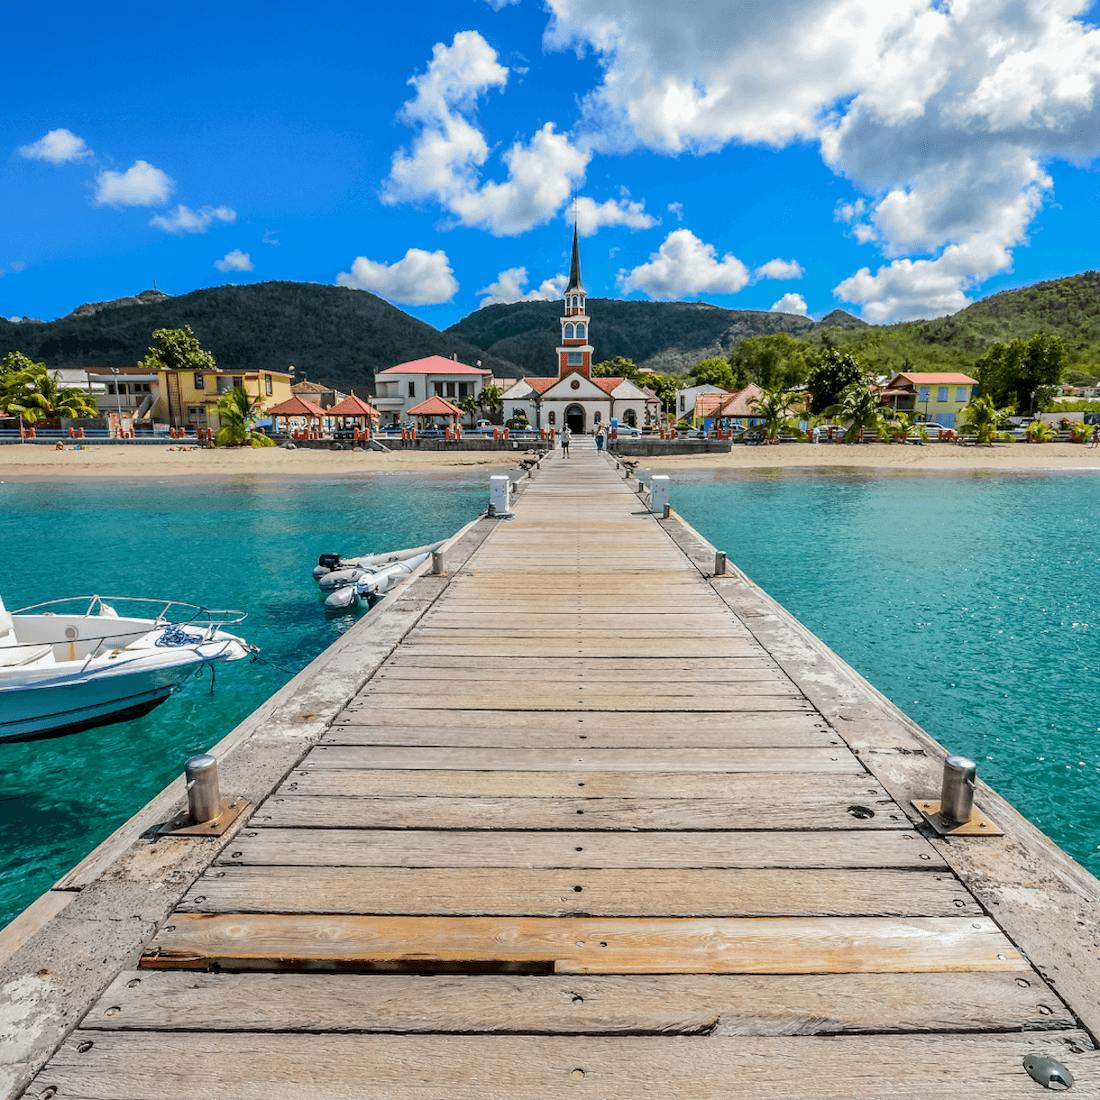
[503,226,659,433]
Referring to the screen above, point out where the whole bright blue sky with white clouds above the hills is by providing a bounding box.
[0,0,1100,327]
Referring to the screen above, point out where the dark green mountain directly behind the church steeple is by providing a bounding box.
[447,298,818,374]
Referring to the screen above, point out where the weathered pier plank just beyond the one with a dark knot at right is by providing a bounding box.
[279,765,882,800]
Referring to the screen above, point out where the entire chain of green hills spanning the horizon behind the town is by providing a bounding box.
[0,272,1100,393]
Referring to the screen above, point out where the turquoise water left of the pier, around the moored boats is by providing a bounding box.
[0,471,488,926]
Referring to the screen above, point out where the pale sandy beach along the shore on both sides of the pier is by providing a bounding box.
[0,443,1100,480]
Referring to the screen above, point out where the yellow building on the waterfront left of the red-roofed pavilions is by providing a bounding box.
[88,366,292,428]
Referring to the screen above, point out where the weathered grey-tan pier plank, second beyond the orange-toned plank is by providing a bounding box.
[220,828,946,870]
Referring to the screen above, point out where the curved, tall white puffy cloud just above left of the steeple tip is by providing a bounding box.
[382,31,590,237]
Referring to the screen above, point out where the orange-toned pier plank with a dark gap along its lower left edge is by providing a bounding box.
[142,913,1029,974]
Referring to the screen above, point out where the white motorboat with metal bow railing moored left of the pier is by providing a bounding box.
[0,596,256,740]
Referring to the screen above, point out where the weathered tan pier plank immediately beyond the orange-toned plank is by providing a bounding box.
[177,854,981,916]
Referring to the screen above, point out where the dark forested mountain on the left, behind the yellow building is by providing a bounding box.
[0,283,516,393]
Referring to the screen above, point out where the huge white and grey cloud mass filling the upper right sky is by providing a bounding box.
[547,0,1100,320]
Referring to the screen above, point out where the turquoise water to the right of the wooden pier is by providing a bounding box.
[673,471,1100,873]
